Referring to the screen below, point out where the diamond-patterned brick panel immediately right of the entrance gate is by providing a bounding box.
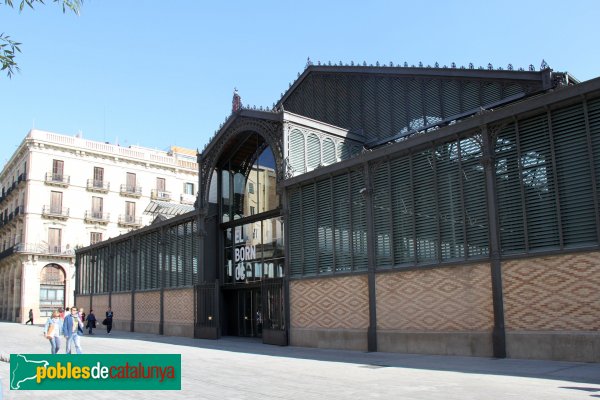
[290,275,369,329]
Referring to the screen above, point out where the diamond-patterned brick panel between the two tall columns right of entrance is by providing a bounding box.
[376,264,493,332]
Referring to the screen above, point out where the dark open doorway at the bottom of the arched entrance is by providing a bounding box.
[223,287,262,337]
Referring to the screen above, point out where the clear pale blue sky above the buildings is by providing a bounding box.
[0,0,600,165]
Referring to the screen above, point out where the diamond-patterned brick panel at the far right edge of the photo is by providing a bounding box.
[502,252,600,331]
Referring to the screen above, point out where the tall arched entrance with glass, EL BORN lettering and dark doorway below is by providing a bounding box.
[215,132,284,337]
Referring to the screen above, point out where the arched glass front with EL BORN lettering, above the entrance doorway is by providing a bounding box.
[219,139,284,284]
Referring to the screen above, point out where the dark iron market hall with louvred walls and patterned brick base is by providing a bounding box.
[75,61,600,362]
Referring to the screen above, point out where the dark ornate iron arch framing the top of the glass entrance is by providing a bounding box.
[198,115,284,207]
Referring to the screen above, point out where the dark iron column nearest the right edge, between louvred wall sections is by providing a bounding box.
[481,125,506,358]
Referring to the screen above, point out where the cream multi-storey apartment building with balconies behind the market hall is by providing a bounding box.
[0,130,198,323]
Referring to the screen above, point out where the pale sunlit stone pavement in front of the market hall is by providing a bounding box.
[0,322,600,400]
